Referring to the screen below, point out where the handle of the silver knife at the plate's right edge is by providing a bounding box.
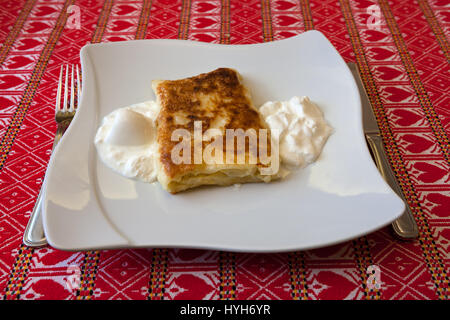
[366,134,419,239]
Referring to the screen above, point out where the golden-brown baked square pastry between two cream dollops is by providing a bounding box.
[152,68,279,193]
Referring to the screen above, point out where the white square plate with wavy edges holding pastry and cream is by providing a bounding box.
[44,31,404,252]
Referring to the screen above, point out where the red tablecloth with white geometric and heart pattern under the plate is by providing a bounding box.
[0,0,450,299]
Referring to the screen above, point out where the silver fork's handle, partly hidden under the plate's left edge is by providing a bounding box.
[23,121,70,248]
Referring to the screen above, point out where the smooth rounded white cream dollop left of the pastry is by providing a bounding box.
[95,101,159,182]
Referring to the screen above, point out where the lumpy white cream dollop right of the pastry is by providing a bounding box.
[259,96,333,168]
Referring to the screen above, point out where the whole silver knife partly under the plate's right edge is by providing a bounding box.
[348,63,419,239]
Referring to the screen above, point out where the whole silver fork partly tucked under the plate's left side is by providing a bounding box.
[23,65,80,247]
